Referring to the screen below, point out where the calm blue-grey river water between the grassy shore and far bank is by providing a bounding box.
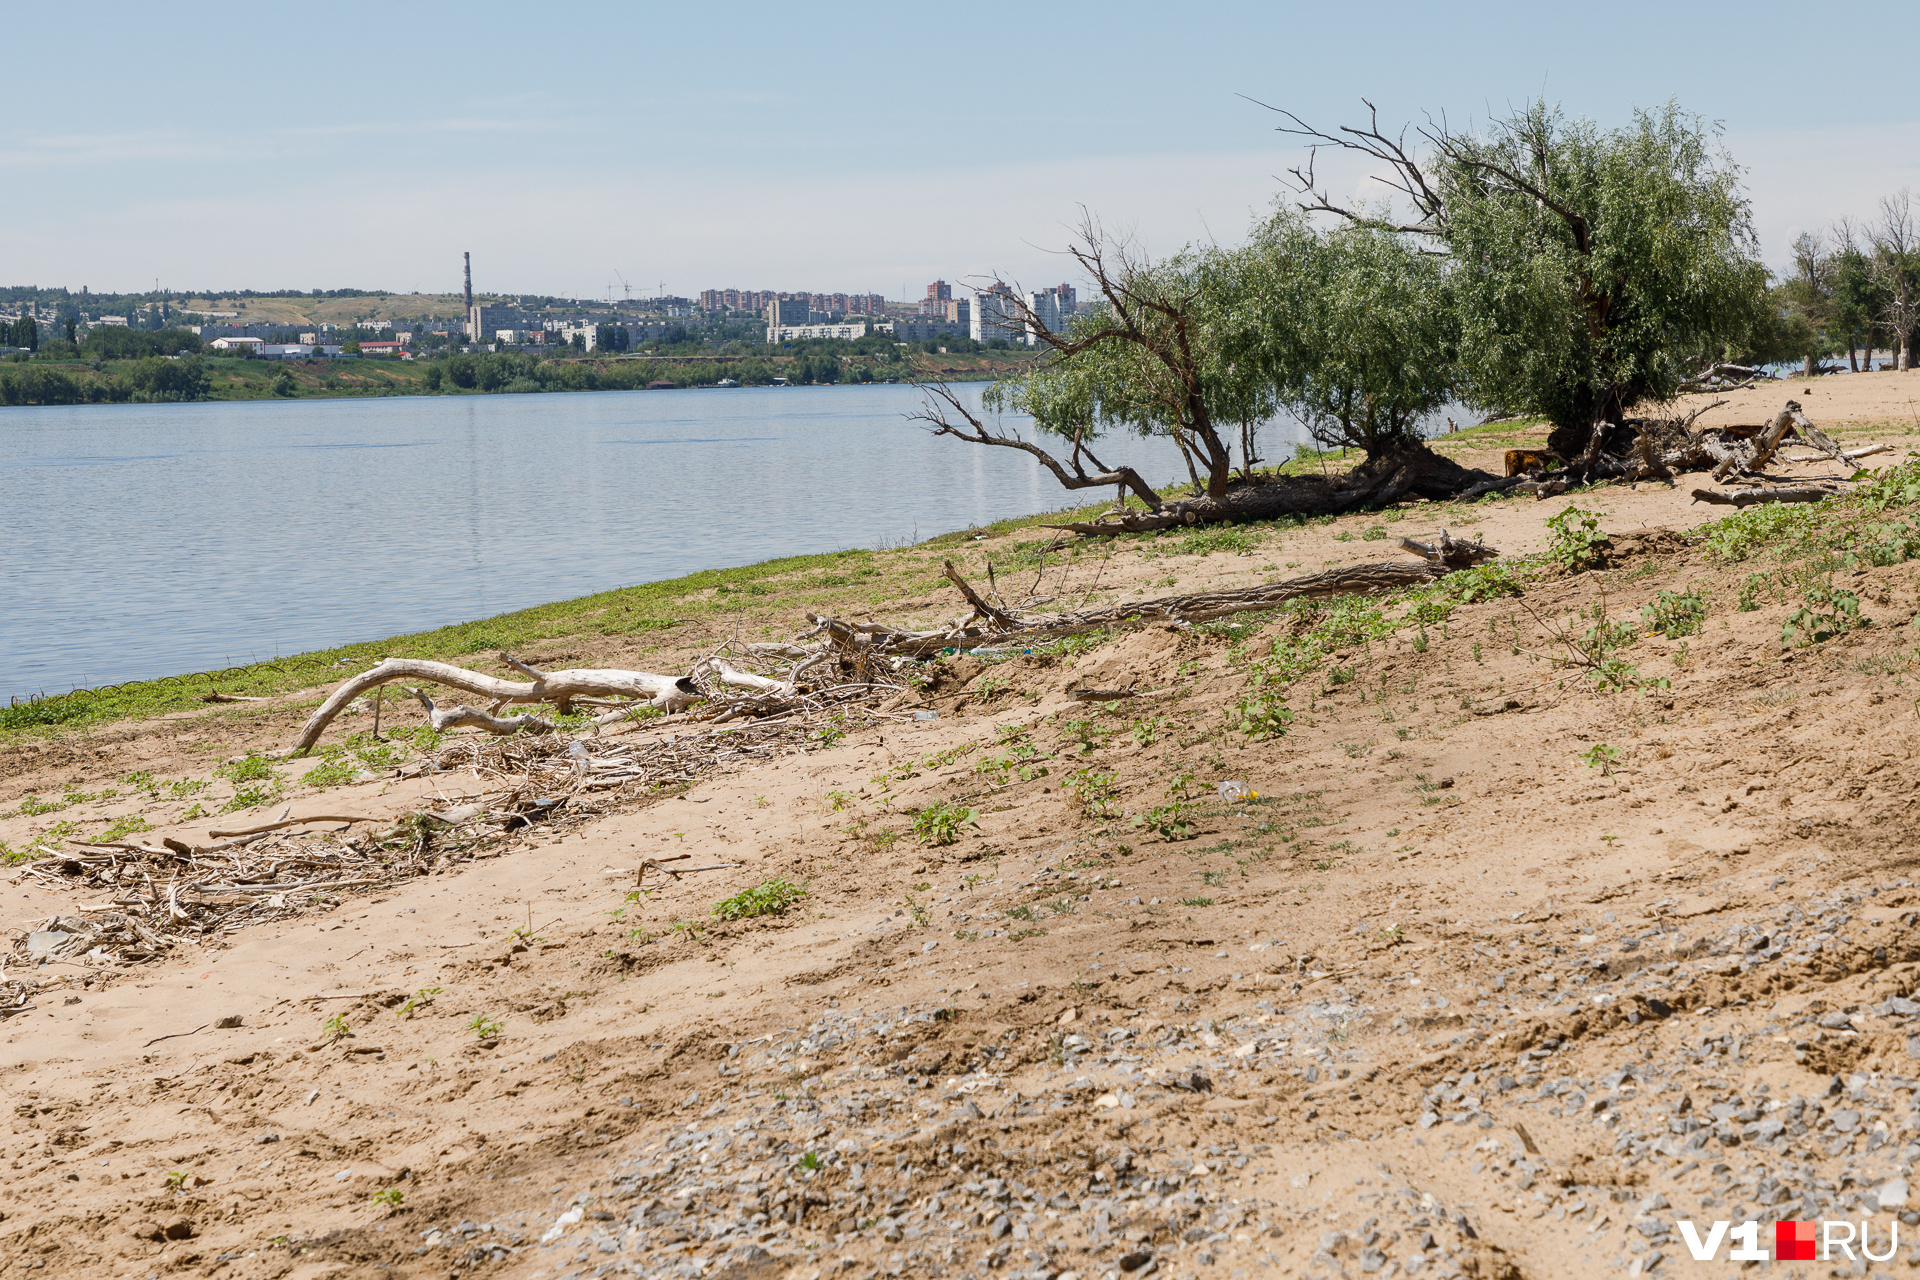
[0,386,1244,699]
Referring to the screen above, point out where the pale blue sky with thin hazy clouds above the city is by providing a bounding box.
[15,0,1920,297]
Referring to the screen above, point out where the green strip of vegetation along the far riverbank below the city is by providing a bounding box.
[0,328,1035,405]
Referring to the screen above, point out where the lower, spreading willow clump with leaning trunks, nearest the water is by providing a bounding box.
[918,211,1484,532]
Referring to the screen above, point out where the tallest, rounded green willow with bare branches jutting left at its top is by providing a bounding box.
[1281,102,1766,452]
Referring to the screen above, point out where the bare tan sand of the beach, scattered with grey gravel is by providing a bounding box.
[0,374,1920,1280]
